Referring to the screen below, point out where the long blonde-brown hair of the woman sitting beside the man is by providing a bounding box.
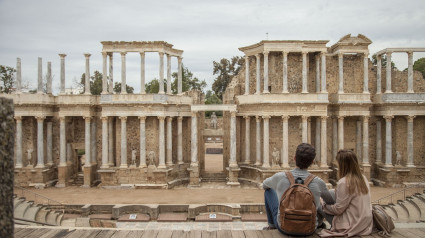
[336,150,369,194]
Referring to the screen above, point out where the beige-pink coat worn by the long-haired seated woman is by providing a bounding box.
[319,177,373,237]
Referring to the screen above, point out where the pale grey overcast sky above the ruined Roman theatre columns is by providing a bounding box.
[0,0,425,92]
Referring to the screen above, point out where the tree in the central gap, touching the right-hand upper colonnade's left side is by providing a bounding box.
[212,56,245,100]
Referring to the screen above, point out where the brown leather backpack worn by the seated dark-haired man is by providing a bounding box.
[279,171,316,236]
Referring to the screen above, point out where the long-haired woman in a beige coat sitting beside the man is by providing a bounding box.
[319,150,373,237]
